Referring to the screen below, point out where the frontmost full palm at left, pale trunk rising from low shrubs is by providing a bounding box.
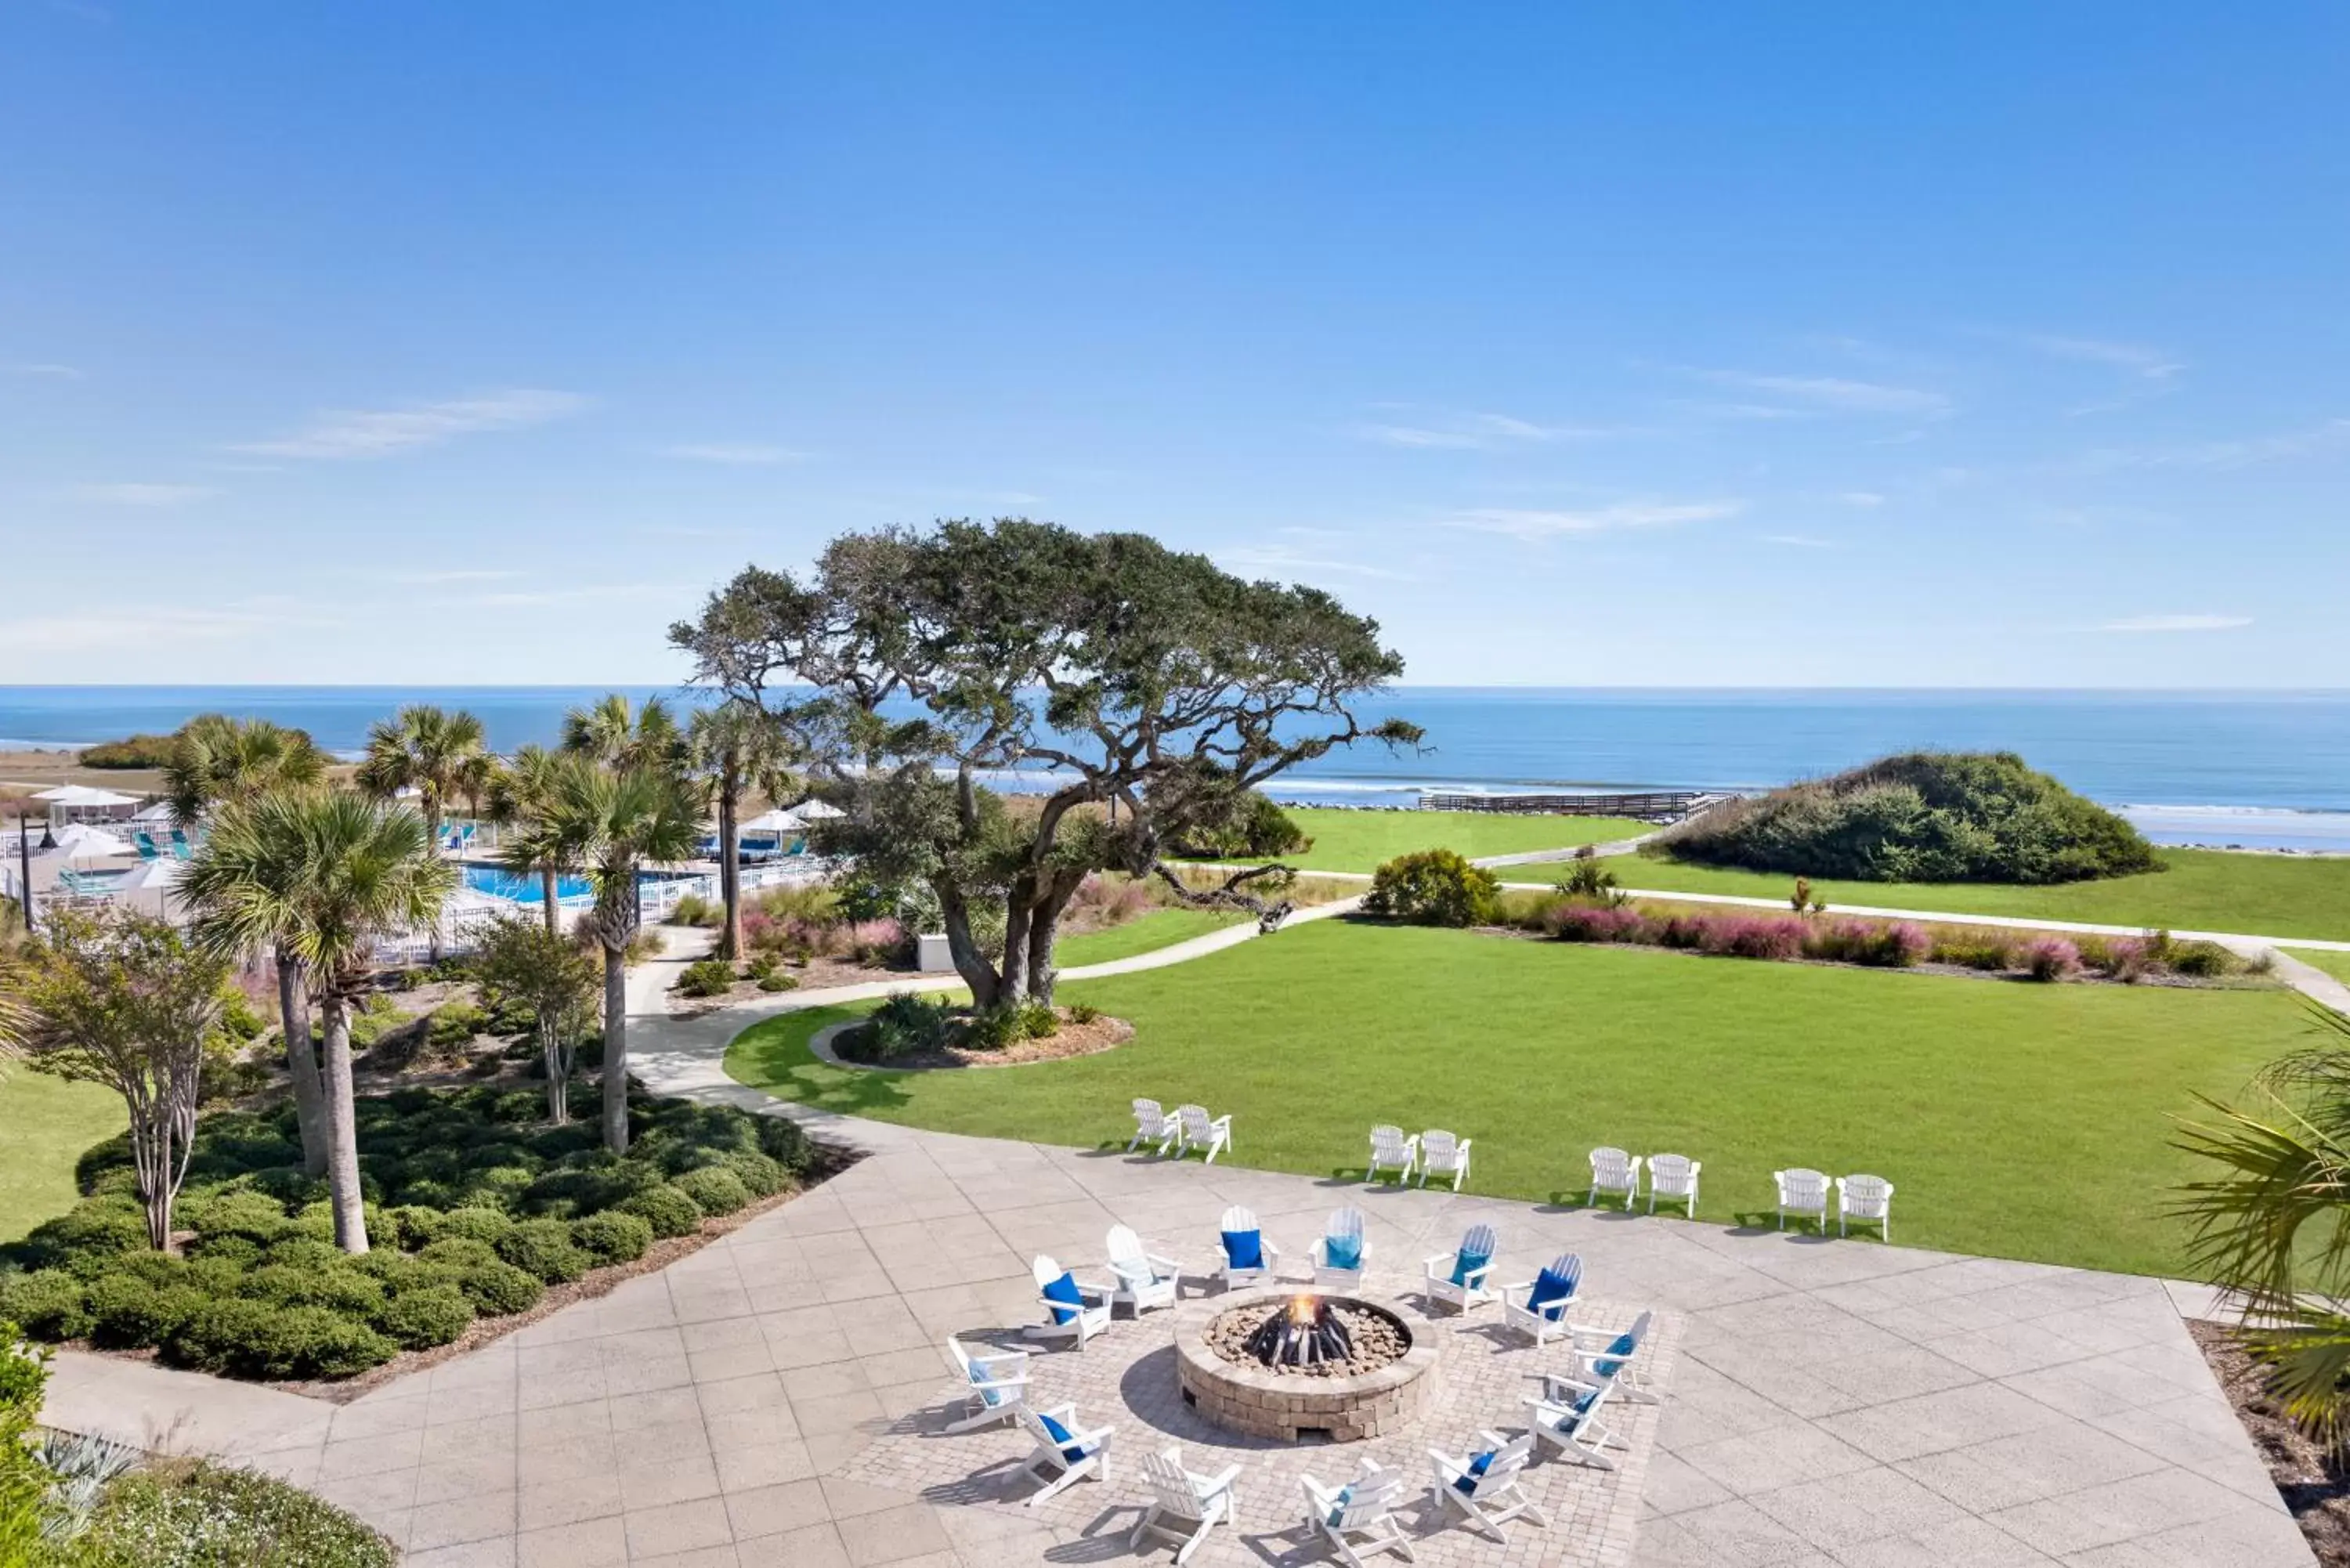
[181,793,458,1253]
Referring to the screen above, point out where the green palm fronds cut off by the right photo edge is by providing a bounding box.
[2178,1004,2350,1453]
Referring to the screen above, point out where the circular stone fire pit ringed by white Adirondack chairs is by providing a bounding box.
[1175,1286,1438,1443]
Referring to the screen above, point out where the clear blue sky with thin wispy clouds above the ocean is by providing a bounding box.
[0,0,2350,686]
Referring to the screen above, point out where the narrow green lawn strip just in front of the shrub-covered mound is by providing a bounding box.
[1504,849,2350,941]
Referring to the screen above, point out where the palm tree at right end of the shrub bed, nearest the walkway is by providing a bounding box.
[536,754,700,1154]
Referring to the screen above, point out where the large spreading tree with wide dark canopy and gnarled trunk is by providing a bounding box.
[670,517,1419,1006]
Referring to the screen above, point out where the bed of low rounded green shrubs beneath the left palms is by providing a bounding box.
[0,1086,813,1378]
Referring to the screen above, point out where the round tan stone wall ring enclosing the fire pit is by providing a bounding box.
[1175,1286,1438,1443]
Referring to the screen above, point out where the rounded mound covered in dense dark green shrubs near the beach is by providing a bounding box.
[1657,752,2162,884]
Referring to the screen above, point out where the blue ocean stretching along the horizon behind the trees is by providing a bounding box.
[0,686,2350,851]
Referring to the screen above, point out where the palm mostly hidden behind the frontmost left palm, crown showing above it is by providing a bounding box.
[162,712,327,1176]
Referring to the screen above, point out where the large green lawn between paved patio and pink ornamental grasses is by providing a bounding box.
[726,922,2310,1272]
